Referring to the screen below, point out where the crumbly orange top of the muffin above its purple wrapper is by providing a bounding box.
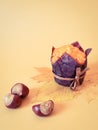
[51,44,86,65]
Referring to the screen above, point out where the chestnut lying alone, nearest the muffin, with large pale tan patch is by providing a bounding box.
[32,100,54,116]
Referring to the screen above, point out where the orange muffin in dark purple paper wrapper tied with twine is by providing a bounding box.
[51,42,92,89]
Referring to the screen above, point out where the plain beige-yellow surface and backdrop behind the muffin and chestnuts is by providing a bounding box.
[0,0,98,130]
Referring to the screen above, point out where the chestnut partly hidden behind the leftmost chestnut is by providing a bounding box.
[11,83,29,98]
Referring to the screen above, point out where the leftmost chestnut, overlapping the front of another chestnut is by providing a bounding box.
[4,93,22,108]
